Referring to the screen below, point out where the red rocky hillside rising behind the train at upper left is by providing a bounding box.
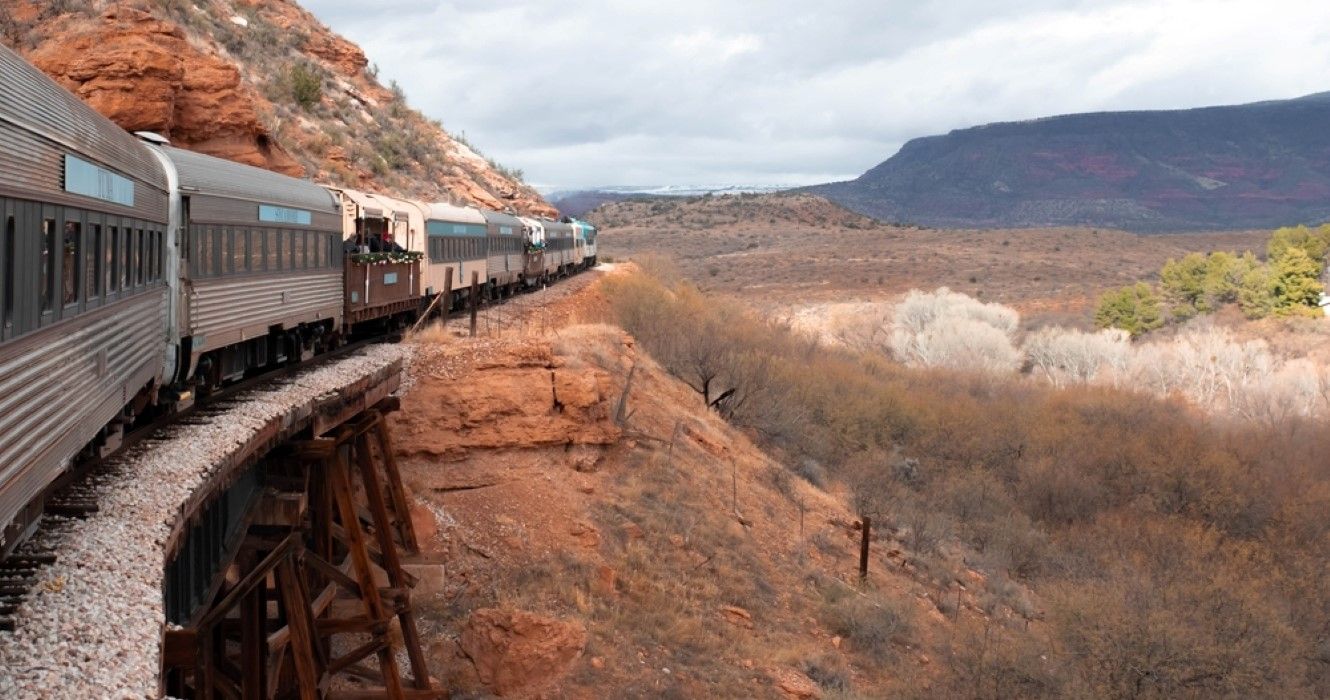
[0,0,555,216]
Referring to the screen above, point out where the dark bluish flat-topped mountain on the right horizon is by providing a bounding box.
[811,93,1330,232]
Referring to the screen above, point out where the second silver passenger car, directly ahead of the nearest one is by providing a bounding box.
[157,146,342,386]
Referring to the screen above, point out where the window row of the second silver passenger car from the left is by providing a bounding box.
[190,226,342,277]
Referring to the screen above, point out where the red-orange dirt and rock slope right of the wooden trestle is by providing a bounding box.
[394,271,1032,699]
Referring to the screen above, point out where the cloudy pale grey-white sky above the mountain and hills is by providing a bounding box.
[303,0,1330,188]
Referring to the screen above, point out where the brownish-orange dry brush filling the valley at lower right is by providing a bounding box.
[606,266,1330,697]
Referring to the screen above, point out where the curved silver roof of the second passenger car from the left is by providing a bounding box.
[161,146,336,214]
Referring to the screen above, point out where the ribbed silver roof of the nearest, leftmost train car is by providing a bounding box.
[0,45,168,200]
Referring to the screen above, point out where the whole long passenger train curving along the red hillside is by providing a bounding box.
[0,47,597,555]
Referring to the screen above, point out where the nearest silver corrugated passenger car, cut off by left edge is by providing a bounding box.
[0,47,174,552]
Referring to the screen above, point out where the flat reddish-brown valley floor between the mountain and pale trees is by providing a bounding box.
[591,194,1269,326]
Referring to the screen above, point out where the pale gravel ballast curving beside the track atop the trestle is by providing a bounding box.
[0,345,410,699]
